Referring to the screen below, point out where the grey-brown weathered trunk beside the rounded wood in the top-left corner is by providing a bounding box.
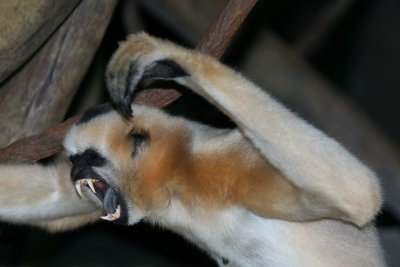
[0,0,117,149]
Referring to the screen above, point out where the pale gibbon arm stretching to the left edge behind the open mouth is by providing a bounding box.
[0,163,102,231]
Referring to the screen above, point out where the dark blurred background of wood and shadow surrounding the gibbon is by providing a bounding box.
[0,0,400,266]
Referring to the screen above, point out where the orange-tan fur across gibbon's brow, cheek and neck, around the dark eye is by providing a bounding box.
[82,108,301,219]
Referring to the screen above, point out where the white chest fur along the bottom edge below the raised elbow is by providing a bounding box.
[147,200,384,267]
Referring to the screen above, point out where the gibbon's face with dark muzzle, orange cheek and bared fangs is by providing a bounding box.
[64,103,188,224]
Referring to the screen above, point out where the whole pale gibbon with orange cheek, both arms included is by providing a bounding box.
[0,34,385,267]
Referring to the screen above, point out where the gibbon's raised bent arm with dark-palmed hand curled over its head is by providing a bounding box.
[106,33,382,226]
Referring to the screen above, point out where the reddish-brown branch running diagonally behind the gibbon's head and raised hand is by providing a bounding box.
[0,0,257,163]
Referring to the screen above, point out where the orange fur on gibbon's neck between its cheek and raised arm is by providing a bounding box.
[187,139,302,218]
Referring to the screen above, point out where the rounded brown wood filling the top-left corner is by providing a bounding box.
[0,0,80,83]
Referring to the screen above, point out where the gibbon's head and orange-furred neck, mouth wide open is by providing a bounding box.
[64,105,319,225]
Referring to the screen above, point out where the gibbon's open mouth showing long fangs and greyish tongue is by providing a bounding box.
[75,178,121,221]
